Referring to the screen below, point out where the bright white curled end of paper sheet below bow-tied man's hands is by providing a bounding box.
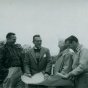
[21,72,44,84]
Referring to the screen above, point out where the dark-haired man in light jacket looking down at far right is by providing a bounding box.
[64,35,88,88]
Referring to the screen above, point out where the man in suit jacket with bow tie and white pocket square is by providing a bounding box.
[24,35,51,88]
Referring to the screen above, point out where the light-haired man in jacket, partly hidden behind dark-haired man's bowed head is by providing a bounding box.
[51,39,72,88]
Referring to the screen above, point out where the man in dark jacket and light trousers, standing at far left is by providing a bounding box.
[0,33,23,88]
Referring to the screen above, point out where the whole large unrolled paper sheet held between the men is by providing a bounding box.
[21,72,74,86]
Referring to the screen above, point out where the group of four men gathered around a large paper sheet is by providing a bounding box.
[0,33,88,88]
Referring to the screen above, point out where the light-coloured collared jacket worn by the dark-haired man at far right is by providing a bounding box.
[70,45,88,76]
